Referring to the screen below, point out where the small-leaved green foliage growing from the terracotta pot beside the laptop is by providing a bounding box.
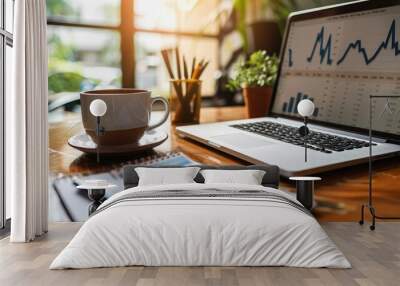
[227,51,279,91]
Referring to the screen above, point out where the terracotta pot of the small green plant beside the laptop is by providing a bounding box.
[243,86,272,118]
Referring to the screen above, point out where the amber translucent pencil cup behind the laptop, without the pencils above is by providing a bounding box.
[169,79,201,125]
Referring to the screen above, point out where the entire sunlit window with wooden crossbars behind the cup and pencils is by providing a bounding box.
[47,0,220,114]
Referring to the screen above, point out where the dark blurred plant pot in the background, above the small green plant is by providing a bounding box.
[247,21,282,55]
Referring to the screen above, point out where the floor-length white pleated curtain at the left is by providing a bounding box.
[6,0,48,242]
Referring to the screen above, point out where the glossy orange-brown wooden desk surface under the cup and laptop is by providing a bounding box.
[49,107,400,221]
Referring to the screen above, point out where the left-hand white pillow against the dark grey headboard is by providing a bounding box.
[135,167,200,186]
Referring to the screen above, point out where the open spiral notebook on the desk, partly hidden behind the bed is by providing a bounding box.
[50,152,198,221]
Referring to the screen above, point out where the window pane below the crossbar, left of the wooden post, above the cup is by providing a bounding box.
[47,26,121,95]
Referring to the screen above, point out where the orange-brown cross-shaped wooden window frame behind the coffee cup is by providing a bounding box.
[47,0,220,88]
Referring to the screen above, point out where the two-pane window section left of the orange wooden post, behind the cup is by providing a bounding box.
[46,0,122,115]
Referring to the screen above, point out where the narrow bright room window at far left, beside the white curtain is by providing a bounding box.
[0,0,14,229]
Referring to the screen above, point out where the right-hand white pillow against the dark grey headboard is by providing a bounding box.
[200,170,265,185]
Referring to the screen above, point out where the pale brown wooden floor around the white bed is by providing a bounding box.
[0,222,400,286]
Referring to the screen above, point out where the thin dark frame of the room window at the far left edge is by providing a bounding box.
[0,0,15,230]
